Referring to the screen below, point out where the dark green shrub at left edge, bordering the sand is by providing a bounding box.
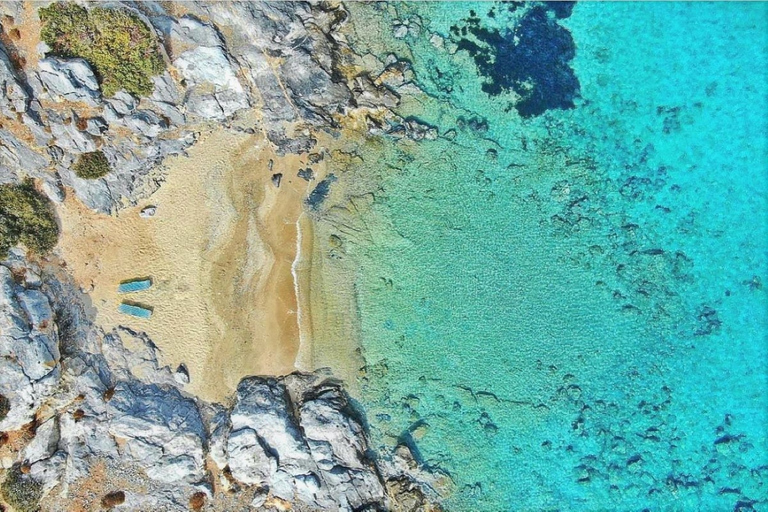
[0,179,59,257]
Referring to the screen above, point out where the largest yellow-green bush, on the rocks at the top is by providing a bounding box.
[39,3,165,96]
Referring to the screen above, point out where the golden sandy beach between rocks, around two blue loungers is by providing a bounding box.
[59,129,320,401]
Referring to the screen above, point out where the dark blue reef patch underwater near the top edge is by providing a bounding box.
[451,4,579,117]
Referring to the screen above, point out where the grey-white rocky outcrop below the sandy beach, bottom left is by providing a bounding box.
[0,251,438,510]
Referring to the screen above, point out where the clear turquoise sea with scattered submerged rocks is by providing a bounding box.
[338,2,768,511]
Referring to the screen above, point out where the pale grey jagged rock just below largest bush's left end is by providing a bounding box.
[35,57,101,106]
